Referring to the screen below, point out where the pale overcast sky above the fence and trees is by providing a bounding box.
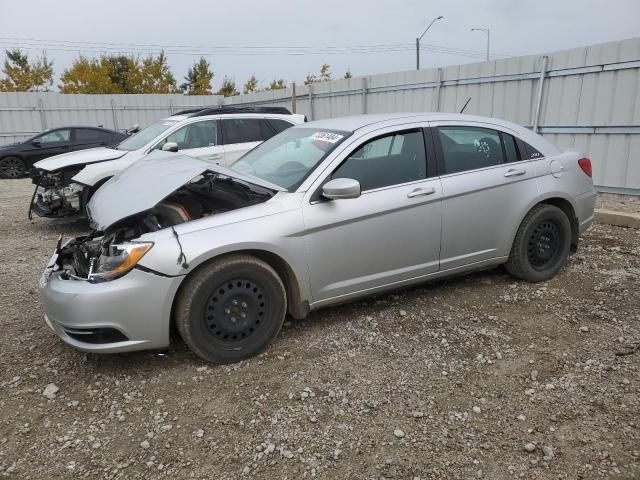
[0,0,640,88]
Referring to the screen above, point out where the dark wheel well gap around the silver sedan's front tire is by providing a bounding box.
[171,250,309,336]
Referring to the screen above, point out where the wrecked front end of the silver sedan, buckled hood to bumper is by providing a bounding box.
[40,155,275,353]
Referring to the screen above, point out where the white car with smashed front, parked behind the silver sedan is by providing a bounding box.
[29,106,305,218]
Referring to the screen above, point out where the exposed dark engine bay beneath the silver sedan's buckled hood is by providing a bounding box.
[56,172,275,281]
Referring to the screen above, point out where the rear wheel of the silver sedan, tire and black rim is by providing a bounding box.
[505,204,571,282]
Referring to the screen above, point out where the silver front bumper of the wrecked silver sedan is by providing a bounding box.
[39,248,184,353]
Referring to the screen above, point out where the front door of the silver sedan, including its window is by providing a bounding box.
[303,126,442,302]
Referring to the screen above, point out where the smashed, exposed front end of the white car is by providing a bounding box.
[28,168,87,219]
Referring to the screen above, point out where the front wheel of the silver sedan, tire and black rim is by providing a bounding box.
[175,255,287,363]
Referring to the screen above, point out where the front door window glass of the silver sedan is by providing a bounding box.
[331,130,427,191]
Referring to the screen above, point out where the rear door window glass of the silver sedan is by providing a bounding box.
[438,126,504,173]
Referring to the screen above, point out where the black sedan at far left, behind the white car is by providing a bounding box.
[0,127,127,178]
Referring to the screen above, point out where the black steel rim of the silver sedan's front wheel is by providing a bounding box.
[203,278,268,345]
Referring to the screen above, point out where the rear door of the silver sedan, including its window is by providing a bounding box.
[432,122,537,270]
